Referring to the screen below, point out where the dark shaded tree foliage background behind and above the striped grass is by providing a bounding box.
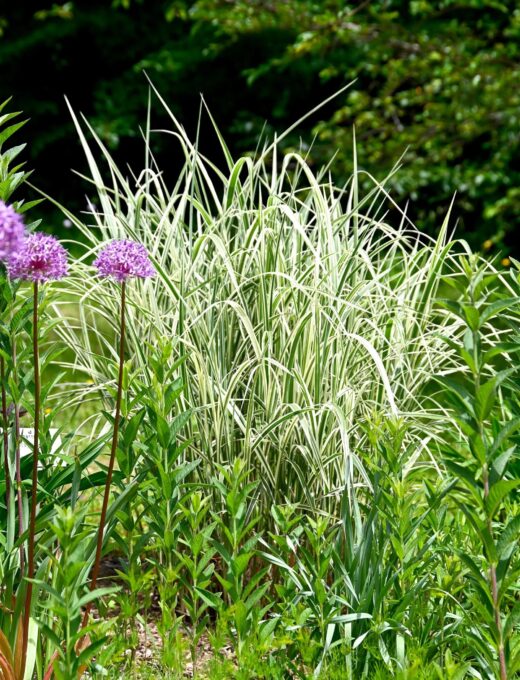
[0,0,520,254]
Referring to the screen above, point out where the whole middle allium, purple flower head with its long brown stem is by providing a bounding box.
[7,232,68,677]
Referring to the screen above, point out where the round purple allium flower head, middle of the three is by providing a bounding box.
[7,232,67,281]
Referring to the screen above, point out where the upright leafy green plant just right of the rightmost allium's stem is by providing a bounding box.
[127,340,200,669]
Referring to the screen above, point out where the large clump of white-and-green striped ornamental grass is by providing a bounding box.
[48,91,466,510]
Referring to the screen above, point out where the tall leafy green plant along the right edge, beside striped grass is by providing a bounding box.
[442,257,520,680]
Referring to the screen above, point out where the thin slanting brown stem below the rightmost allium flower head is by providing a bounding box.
[82,281,126,627]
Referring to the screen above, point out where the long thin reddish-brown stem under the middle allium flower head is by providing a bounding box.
[20,281,41,678]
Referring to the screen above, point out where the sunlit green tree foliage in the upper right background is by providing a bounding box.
[192,0,520,248]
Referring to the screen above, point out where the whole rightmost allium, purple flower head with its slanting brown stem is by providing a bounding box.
[83,239,155,626]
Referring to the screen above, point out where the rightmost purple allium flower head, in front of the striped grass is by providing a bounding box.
[94,239,155,282]
